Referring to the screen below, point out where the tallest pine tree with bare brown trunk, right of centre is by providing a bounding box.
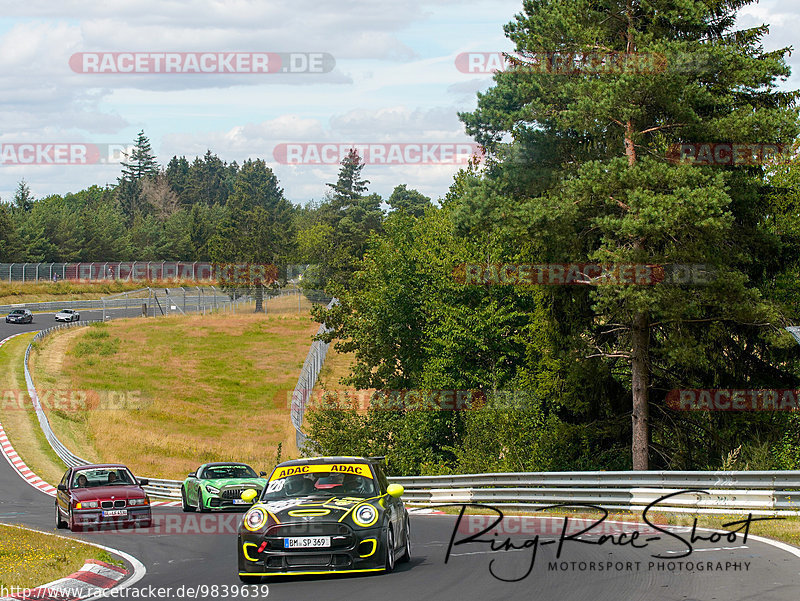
[457,0,798,469]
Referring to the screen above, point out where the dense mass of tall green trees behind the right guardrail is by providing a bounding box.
[308,0,800,474]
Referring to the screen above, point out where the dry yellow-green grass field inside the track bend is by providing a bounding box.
[31,314,319,479]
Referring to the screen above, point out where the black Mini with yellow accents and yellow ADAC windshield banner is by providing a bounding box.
[237,457,411,584]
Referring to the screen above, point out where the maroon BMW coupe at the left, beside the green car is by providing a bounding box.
[56,464,152,532]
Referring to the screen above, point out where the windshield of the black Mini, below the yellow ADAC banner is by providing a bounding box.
[261,471,378,501]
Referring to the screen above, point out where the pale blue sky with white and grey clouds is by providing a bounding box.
[0,0,800,204]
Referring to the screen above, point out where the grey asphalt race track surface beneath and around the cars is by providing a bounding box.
[0,311,800,601]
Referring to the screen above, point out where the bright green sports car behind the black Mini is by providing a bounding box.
[181,462,267,512]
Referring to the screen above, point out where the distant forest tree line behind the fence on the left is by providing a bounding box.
[0,131,430,288]
